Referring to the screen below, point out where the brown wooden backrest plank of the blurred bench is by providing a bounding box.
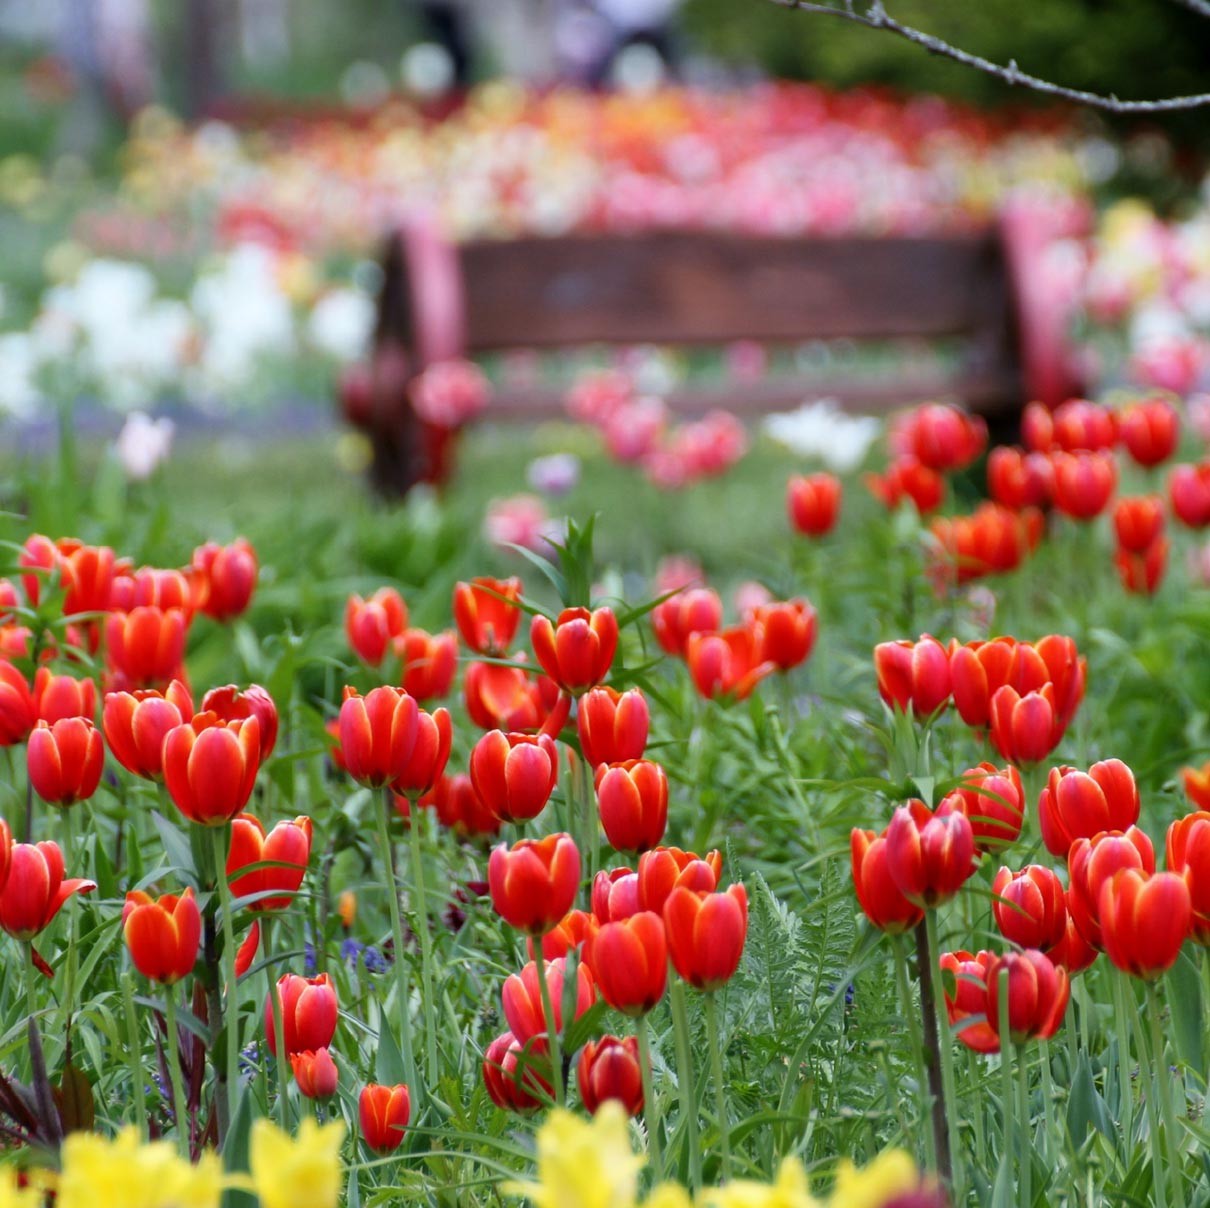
[461,231,1008,353]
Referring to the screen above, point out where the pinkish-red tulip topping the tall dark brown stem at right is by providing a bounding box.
[886,801,975,909]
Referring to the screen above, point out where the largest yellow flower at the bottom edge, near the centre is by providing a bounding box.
[503,1100,644,1208]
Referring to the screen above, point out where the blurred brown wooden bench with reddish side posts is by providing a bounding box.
[342,210,1078,494]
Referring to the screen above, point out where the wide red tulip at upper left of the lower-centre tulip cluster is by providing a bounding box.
[488,834,580,939]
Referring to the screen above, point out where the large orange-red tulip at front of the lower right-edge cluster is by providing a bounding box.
[1099,868,1193,982]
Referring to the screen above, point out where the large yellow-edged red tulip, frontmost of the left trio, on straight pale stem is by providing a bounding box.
[163,713,260,827]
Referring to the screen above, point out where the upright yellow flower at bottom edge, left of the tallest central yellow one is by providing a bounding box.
[250,1117,345,1208]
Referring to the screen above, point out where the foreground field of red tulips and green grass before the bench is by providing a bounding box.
[0,380,1210,1208]
